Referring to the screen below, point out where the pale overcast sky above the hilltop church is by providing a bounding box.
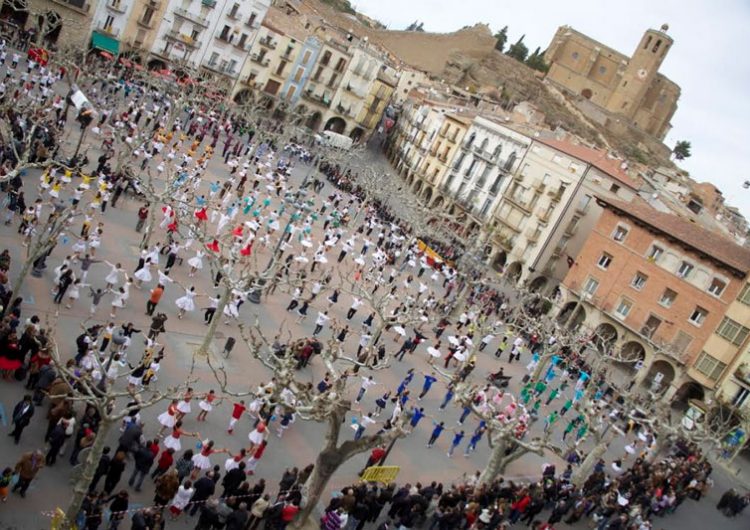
[352,0,750,220]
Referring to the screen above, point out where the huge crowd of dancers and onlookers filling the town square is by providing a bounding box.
[0,39,741,530]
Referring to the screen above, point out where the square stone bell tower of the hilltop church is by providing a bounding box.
[606,24,673,119]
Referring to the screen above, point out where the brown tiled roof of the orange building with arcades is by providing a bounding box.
[597,197,750,277]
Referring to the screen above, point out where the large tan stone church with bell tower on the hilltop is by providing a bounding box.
[544,24,680,140]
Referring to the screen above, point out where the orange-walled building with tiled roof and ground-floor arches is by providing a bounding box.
[557,197,750,400]
